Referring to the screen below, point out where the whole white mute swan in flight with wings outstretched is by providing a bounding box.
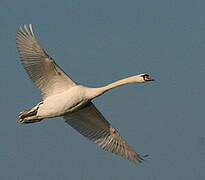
[16,24,154,163]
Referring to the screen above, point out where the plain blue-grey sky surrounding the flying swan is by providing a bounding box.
[0,0,205,180]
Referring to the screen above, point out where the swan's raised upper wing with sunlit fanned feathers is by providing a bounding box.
[16,25,75,98]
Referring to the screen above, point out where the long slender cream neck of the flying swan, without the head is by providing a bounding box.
[90,76,141,99]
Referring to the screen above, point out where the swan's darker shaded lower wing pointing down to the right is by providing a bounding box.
[64,102,143,163]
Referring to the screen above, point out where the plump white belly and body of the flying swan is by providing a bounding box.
[37,86,88,118]
